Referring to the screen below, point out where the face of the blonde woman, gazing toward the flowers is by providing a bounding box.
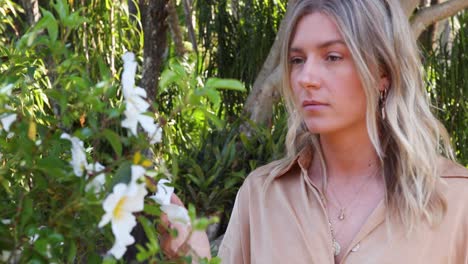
[288,13,366,135]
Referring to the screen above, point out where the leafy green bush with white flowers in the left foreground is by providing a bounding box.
[0,1,243,263]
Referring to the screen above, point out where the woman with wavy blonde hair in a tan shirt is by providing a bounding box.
[161,0,468,264]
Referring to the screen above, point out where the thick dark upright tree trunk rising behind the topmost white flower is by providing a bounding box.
[139,0,169,102]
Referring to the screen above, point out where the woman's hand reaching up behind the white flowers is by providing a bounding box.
[158,194,211,260]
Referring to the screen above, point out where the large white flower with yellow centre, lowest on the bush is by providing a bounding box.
[99,182,147,259]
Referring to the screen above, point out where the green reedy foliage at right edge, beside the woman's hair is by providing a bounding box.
[425,12,468,166]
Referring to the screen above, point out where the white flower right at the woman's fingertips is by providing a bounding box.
[150,179,190,225]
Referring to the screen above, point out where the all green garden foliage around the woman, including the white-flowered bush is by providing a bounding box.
[0,0,468,263]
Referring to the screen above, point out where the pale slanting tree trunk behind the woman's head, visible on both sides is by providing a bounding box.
[244,0,468,125]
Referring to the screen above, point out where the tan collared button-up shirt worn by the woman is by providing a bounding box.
[218,152,468,264]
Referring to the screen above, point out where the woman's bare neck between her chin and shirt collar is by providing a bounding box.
[320,125,378,182]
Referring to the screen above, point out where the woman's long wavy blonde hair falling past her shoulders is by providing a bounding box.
[267,0,453,229]
